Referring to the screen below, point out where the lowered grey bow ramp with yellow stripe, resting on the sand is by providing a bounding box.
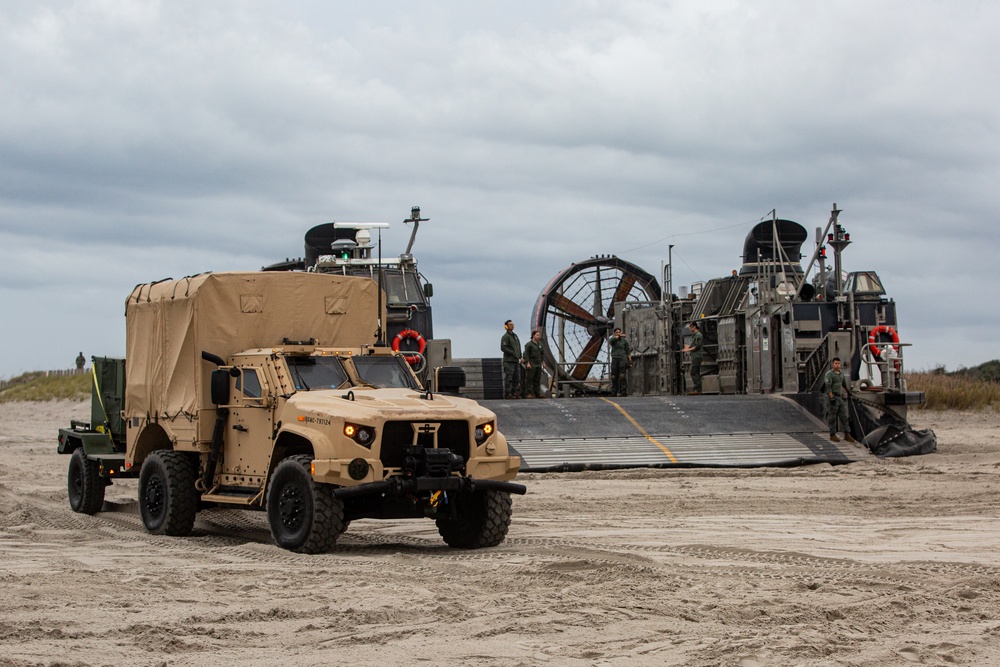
[483,395,872,472]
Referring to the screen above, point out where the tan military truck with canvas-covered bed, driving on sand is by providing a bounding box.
[60,273,525,553]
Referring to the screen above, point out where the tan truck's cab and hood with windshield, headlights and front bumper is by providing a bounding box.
[196,343,519,505]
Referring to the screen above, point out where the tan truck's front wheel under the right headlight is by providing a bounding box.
[436,489,513,549]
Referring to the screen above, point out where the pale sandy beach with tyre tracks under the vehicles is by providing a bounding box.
[0,402,1000,667]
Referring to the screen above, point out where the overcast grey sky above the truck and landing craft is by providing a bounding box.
[0,0,1000,377]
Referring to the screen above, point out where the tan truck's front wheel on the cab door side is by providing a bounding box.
[267,456,347,554]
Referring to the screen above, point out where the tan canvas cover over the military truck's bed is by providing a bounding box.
[125,272,385,435]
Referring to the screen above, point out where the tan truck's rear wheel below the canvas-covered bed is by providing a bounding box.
[139,450,198,536]
